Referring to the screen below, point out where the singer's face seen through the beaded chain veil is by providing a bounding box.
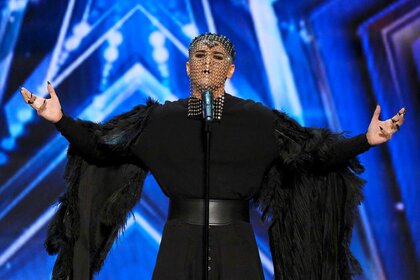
[187,41,235,91]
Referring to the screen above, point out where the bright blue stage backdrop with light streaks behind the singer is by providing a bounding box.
[0,0,420,279]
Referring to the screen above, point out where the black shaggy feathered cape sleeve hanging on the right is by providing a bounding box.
[256,111,370,280]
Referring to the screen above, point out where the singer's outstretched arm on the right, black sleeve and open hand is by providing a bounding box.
[274,106,405,170]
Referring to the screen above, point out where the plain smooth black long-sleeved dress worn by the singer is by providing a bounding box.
[50,94,369,280]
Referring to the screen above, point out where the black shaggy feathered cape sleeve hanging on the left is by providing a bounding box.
[45,100,157,279]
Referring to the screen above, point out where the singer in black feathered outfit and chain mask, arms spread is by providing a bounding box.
[21,33,405,280]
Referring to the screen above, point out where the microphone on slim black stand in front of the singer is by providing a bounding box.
[202,90,214,280]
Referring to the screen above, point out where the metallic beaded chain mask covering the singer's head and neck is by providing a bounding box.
[188,33,235,120]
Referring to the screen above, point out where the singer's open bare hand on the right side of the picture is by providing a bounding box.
[366,105,406,146]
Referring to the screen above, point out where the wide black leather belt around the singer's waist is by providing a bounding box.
[168,198,249,226]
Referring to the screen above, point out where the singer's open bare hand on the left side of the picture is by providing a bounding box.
[20,82,63,123]
